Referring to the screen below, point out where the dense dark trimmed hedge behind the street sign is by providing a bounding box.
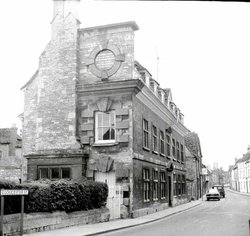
[0,180,108,214]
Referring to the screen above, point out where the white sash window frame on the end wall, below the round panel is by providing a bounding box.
[95,110,116,144]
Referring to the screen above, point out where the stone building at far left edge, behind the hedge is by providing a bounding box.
[0,127,26,183]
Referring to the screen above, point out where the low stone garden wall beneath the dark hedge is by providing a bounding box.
[3,208,109,236]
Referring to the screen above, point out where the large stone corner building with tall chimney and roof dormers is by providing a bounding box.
[22,0,189,219]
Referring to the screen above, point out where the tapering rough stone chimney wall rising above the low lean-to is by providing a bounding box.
[23,11,80,155]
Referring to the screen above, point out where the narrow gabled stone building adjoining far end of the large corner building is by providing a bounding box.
[185,132,203,200]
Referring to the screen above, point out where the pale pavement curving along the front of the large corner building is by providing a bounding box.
[24,198,205,236]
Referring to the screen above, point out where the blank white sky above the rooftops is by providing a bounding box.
[0,0,250,170]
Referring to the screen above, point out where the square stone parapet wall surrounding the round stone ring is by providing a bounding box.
[79,22,138,84]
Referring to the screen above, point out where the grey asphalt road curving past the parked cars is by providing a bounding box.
[99,191,250,236]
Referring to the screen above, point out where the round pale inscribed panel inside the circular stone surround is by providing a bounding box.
[95,49,115,71]
